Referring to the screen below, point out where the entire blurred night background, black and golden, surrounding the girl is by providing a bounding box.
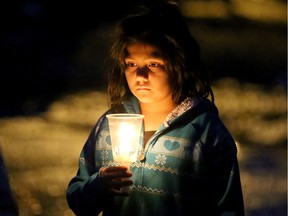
[0,0,287,216]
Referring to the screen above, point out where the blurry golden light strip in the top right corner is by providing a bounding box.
[179,0,287,23]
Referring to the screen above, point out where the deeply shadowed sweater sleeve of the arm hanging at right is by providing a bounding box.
[205,112,244,216]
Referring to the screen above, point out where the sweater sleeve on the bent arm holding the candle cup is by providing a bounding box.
[66,115,108,216]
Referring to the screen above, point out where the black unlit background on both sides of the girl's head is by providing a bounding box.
[0,0,287,117]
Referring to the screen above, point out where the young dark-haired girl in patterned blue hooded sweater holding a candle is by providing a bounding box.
[67,3,244,216]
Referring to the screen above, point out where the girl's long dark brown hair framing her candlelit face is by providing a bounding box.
[108,3,214,107]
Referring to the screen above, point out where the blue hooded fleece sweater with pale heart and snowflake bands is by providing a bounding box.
[67,97,244,216]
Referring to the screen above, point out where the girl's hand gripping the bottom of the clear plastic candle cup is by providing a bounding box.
[100,166,133,196]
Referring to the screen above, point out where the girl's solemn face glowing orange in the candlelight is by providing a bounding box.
[124,43,172,104]
